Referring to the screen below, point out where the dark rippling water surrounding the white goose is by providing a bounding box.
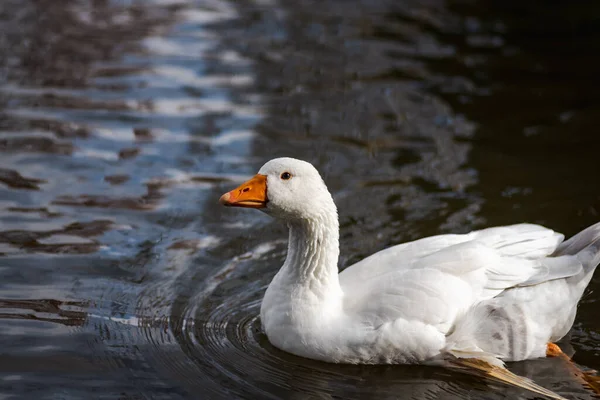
[0,0,600,399]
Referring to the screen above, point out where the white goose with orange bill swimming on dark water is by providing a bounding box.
[220,158,600,398]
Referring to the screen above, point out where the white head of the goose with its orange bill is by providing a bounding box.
[219,157,337,221]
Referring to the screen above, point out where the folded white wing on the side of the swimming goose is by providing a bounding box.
[340,224,582,334]
